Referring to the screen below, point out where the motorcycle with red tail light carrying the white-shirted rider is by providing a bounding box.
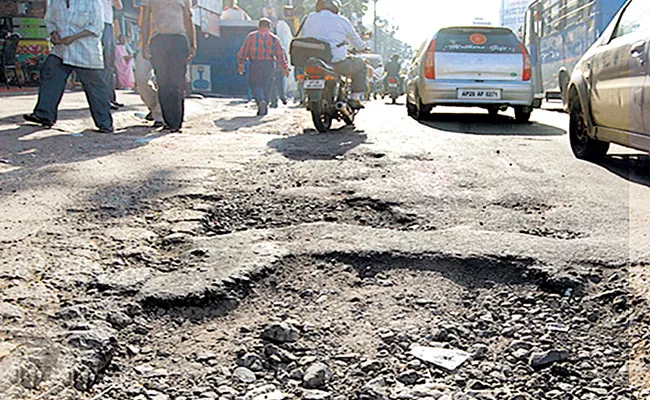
[303,58,358,133]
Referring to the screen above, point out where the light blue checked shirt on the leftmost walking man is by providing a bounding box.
[45,0,104,69]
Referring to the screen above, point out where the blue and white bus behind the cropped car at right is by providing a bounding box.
[523,0,627,100]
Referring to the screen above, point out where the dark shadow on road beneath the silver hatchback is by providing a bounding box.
[420,112,566,136]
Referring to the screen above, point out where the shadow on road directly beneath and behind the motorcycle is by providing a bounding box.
[268,126,368,161]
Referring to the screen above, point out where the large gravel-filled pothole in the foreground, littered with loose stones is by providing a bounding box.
[101,254,629,399]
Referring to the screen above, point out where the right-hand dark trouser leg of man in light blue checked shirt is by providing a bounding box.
[75,68,113,133]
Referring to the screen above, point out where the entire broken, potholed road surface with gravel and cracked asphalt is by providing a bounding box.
[0,94,650,400]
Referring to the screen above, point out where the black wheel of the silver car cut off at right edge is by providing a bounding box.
[569,100,609,162]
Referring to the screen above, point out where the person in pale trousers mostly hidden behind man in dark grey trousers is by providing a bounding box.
[135,7,165,128]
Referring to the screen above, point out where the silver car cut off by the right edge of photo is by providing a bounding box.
[567,0,650,161]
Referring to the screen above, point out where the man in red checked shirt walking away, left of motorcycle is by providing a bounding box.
[237,18,289,115]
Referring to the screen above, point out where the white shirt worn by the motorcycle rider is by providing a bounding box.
[300,10,366,63]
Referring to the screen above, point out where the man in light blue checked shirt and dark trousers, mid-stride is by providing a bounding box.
[23,0,113,133]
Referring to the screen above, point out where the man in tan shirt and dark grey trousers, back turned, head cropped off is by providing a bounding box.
[142,0,196,132]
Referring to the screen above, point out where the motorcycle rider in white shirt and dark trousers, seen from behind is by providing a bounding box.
[300,0,368,109]
